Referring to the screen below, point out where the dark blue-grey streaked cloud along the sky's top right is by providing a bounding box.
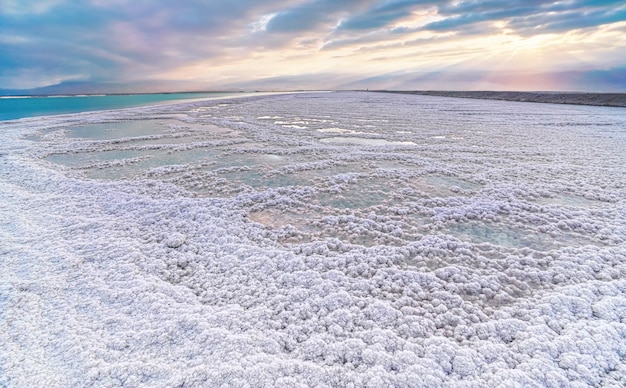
[323,0,626,56]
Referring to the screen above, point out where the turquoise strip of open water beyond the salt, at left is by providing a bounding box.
[0,92,244,121]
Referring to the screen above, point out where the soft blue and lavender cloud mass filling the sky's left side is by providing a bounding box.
[0,0,285,86]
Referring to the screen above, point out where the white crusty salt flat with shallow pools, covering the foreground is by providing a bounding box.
[0,92,626,387]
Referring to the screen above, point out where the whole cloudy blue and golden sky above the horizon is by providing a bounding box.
[0,0,626,92]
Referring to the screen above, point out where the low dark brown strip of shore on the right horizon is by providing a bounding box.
[371,90,626,108]
